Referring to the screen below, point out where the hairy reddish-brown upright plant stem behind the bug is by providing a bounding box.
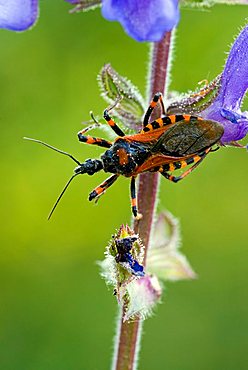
[112,32,171,370]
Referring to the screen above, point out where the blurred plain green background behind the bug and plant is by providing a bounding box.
[0,0,248,370]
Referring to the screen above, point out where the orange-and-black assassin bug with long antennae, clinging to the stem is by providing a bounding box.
[24,93,224,218]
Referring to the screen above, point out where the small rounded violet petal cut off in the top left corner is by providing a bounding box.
[0,0,38,31]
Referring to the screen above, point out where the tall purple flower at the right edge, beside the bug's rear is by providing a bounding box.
[201,26,248,144]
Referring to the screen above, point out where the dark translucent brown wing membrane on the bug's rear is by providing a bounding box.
[151,120,224,157]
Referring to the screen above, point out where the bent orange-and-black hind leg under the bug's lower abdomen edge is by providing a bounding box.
[159,149,207,182]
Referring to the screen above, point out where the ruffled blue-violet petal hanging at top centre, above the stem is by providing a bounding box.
[102,0,179,41]
